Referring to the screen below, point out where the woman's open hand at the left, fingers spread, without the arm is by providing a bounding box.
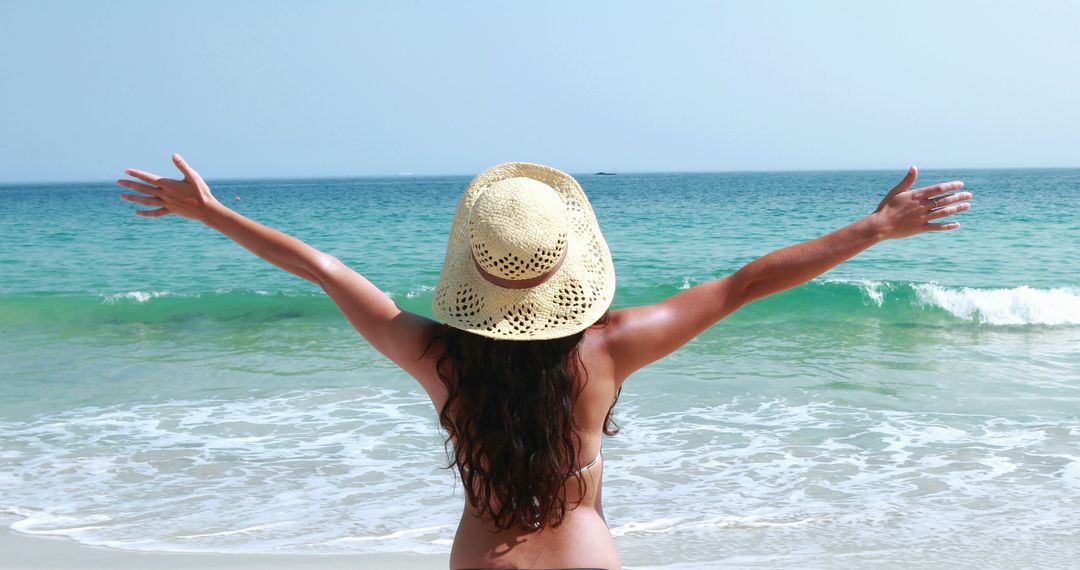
[117,154,222,222]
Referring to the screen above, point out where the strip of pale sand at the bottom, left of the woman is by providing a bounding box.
[0,529,449,570]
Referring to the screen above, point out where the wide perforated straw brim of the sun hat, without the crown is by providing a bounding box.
[432,162,616,340]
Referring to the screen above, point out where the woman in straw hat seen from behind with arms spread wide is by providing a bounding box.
[118,155,971,569]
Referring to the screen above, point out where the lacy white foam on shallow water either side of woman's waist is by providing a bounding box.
[0,380,1080,567]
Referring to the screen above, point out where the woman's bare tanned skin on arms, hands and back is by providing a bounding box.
[117,154,971,569]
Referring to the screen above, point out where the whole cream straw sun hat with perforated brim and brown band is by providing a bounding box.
[432,162,615,340]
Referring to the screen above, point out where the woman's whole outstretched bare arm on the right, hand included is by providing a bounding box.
[603,166,971,382]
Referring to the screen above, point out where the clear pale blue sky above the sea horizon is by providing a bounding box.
[0,0,1080,181]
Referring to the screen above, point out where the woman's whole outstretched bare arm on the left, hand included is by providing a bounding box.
[117,154,438,394]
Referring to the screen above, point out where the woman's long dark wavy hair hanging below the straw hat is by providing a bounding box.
[436,313,619,530]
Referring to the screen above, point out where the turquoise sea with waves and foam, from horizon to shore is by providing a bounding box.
[0,169,1080,568]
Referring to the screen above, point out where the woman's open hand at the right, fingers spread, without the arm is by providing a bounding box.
[867,166,971,240]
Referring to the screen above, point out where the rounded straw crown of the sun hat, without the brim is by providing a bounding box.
[469,177,567,281]
